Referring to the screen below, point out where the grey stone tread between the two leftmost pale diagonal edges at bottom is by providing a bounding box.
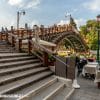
[25,81,63,100]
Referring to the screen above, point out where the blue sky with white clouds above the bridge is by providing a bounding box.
[0,0,100,28]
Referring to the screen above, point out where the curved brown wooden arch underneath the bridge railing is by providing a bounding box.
[52,32,88,52]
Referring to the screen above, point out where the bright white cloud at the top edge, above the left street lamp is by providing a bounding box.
[8,0,40,8]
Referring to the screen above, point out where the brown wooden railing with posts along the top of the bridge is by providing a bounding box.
[0,25,72,51]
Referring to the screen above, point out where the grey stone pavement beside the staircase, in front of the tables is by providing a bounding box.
[70,76,100,100]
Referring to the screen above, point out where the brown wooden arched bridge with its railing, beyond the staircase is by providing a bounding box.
[0,25,88,52]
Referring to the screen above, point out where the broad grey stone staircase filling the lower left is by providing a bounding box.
[0,40,74,100]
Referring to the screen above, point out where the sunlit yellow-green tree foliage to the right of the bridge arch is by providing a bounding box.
[80,20,99,50]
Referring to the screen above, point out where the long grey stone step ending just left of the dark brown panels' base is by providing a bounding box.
[0,71,53,94]
